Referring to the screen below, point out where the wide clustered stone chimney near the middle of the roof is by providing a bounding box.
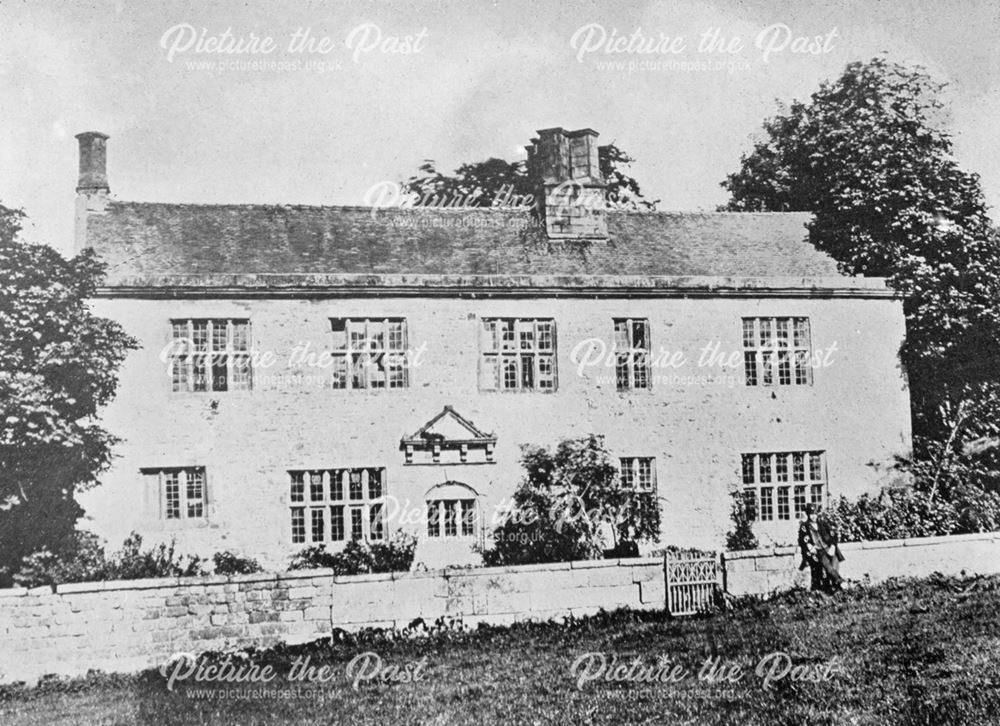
[525,127,608,239]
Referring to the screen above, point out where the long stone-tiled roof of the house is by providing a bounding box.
[87,201,839,287]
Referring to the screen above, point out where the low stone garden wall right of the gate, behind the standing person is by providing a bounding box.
[725,532,1000,595]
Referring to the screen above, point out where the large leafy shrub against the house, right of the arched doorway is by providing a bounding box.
[484,435,660,565]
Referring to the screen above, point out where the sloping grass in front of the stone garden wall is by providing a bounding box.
[0,578,1000,726]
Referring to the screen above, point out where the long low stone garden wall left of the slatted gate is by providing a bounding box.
[0,559,664,683]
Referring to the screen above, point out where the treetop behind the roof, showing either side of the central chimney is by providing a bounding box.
[403,144,659,211]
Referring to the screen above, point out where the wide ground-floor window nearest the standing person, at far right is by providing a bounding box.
[743,451,826,522]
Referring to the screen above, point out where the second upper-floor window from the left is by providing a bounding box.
[330,318,410,389]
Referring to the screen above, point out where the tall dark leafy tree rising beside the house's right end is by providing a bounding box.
[723,57,1000,456]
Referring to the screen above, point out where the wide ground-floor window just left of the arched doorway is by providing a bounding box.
[288,468,385,544]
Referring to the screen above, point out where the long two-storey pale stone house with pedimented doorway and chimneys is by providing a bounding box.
[76,128,910,566]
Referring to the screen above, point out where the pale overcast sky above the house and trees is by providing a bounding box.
[0,0,1000,250]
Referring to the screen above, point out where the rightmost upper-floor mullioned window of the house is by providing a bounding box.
[743,318,812,386]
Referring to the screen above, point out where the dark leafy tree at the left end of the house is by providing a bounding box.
[0,205,137,583]
